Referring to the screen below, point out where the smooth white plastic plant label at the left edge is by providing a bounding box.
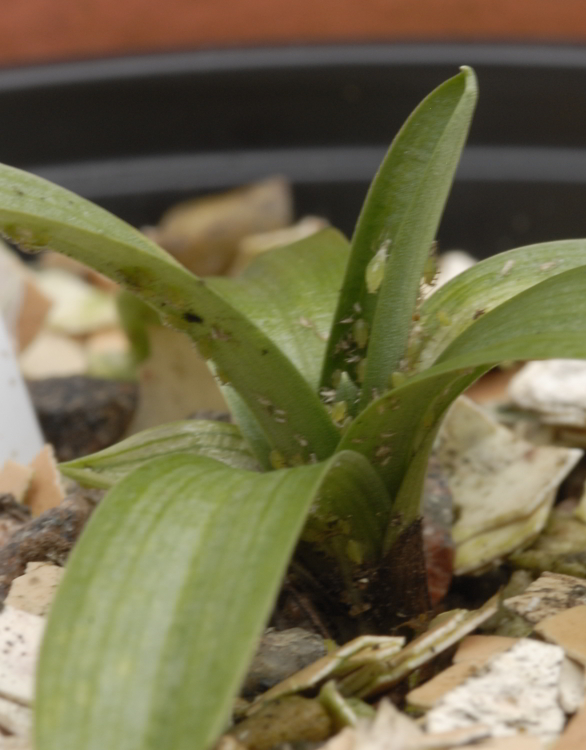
[0,315,44,466]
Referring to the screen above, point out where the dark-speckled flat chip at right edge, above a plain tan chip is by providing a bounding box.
[503,573,586,625]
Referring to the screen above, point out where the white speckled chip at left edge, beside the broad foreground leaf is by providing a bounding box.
[0,607,45,706]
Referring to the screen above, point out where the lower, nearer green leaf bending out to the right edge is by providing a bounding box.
[338,266,586,549]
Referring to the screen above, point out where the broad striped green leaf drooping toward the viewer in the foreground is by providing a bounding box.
[35,453,390,750]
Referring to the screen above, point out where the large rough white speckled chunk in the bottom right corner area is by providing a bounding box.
[426,638,565,741]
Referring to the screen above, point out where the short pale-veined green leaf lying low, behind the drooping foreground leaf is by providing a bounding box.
[59,419,258,489]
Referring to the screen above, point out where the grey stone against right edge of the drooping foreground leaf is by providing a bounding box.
[241,628,326,698]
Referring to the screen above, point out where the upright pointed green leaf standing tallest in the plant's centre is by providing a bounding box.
[322,68,476,408]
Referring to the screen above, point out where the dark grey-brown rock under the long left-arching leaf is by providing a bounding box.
[28,375,138,461]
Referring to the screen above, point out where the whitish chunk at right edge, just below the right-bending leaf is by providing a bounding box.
[509,359,586,428]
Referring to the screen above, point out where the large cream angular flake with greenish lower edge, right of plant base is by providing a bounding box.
[437,397,582,574]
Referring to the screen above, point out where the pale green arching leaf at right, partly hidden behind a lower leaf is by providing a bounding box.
[410,240,586,372]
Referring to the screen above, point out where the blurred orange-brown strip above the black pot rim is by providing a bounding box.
[0,0,586,64]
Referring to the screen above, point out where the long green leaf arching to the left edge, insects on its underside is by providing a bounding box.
[0,166,338,459]
